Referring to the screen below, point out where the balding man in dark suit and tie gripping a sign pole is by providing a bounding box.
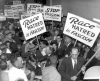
[59,47,85,81]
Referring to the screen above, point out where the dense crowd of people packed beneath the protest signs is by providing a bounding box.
[0,19,100,81]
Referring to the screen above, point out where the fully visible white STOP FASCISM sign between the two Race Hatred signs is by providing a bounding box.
[44,6,62,21]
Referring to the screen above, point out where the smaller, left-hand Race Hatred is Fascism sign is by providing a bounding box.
[20,13,46,40]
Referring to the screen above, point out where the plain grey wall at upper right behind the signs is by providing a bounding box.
[47,0,100,20]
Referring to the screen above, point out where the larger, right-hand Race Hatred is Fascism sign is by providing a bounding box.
[63,13,100,47]
